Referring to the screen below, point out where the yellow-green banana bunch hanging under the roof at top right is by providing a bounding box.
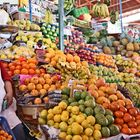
[92,2,109,18]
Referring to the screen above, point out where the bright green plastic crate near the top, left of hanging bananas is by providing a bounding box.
[73,7,89,18]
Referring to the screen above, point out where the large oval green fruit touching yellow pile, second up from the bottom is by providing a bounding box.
[95,114,108,126]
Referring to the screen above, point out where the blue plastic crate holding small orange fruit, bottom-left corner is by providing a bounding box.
[0,116,16,140]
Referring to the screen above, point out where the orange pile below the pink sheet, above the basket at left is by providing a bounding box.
[19,74,61,104]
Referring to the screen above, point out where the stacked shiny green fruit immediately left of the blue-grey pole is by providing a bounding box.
[41,23,59,42]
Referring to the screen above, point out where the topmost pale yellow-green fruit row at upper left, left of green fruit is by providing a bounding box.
[8,19,40,31]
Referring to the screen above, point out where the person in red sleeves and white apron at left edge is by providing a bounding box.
[0,61,26,140]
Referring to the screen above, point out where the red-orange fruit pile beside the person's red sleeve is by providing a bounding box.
[3,58,45,76]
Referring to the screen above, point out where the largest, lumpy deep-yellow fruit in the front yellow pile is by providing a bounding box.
[71,122,83,135]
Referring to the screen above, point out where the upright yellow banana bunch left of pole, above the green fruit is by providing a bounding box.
[43,8,53,23]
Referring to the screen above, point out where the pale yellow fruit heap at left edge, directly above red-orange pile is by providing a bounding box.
[0,45,35,60]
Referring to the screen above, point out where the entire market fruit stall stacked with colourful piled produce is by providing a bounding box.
[0,0,140,140]
